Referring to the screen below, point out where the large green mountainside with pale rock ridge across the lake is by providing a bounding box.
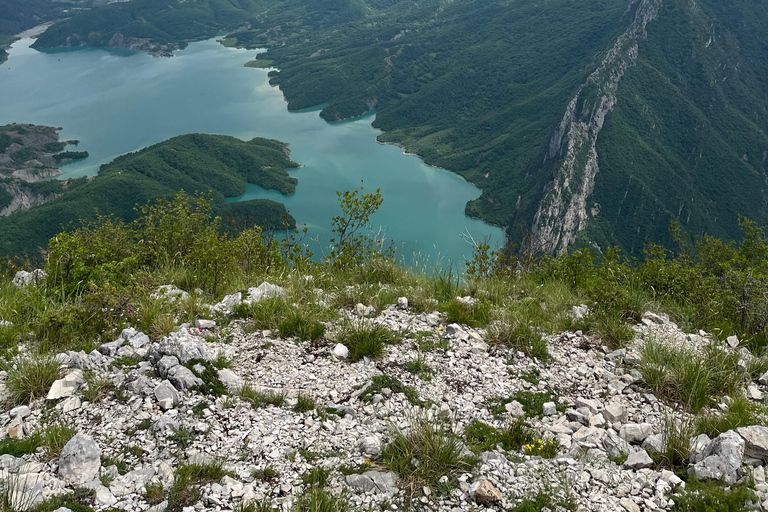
[27,0,768,254]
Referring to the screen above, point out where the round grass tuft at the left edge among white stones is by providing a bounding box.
[5,354,59,403]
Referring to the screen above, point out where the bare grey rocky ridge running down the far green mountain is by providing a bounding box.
[531,0,663,253]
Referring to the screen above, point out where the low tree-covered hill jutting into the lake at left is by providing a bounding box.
[0,134,297,257]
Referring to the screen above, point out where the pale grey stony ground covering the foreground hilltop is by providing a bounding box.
[0,290,768,512]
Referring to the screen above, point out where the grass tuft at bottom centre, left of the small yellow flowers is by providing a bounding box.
[381,417,476,496]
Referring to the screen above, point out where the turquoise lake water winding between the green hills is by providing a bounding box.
[0,35,503,268]
